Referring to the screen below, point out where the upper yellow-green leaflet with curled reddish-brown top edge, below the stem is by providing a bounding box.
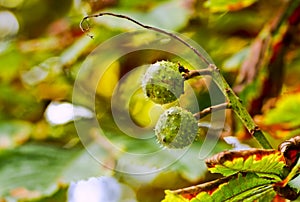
[206,149,285,181]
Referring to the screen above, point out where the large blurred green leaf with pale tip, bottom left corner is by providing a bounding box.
[0,144,110,201]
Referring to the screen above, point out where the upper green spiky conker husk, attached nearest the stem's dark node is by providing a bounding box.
[142,61,184,104]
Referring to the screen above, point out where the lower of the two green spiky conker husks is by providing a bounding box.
[155,107,198,149]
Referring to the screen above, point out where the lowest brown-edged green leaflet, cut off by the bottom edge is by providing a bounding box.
[163,173,276,202]
